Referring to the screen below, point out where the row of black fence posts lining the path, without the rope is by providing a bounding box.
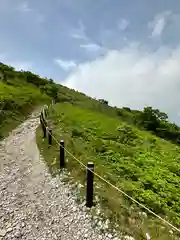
[40,112,94,208]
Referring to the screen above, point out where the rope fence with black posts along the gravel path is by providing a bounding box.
[40,109,180,233]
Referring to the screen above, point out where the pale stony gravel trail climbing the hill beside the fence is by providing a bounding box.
[0,113,118,240]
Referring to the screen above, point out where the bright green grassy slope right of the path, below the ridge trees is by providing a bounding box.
[38,103,180,239]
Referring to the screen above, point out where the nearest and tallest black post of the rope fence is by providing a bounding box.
[86,162,94,207]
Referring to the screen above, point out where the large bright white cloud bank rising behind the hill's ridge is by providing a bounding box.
[64,44,180,123]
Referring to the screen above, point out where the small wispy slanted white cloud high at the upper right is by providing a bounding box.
[148,11,172,37]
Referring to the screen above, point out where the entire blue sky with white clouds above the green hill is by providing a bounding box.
[0,0,180,123]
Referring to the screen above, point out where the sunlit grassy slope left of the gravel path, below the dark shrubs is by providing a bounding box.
[0,80,50,138]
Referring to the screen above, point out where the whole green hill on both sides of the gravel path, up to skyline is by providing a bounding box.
[0,64,180,240]
